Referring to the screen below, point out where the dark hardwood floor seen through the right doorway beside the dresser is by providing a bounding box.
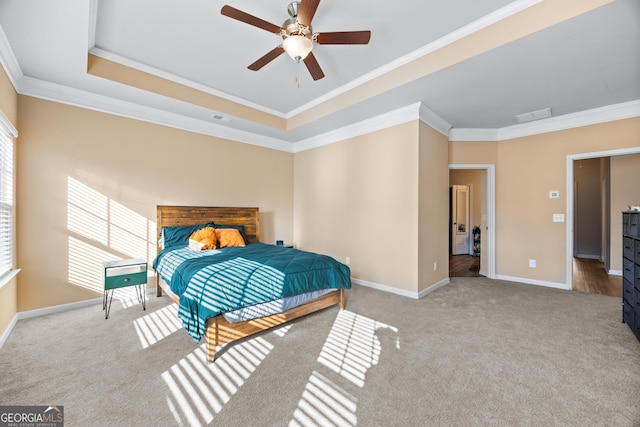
[573,258,622,297]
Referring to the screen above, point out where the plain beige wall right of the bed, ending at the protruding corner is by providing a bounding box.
[294,121,422,292]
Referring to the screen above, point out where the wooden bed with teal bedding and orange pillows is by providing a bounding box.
[153,206,351,363]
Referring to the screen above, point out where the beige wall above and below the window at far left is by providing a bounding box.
[0,66,18,337]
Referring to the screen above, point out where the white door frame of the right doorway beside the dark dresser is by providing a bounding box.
[565,147,640,289]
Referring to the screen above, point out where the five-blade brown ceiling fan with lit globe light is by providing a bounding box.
[220,0,371,80]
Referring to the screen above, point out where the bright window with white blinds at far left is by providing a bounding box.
[0,112,17,276]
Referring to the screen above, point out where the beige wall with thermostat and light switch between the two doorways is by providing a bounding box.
[449,118,640,284]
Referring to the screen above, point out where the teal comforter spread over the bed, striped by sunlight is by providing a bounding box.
[153,243,351,341]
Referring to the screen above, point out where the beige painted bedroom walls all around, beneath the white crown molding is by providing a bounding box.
[0,62,640,328]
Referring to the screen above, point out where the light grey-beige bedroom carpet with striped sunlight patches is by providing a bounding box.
[0,278,640,426]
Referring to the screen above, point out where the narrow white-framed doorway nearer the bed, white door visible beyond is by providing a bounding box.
[449,164,495,278]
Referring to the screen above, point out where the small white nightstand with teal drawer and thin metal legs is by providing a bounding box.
[102,258,147,319]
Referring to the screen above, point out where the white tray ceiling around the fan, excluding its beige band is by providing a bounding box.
[0,0,640,148]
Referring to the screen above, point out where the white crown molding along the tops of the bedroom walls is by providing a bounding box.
[0,16,640,153]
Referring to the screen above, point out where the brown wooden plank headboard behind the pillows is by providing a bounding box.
[157,206,260,252]
